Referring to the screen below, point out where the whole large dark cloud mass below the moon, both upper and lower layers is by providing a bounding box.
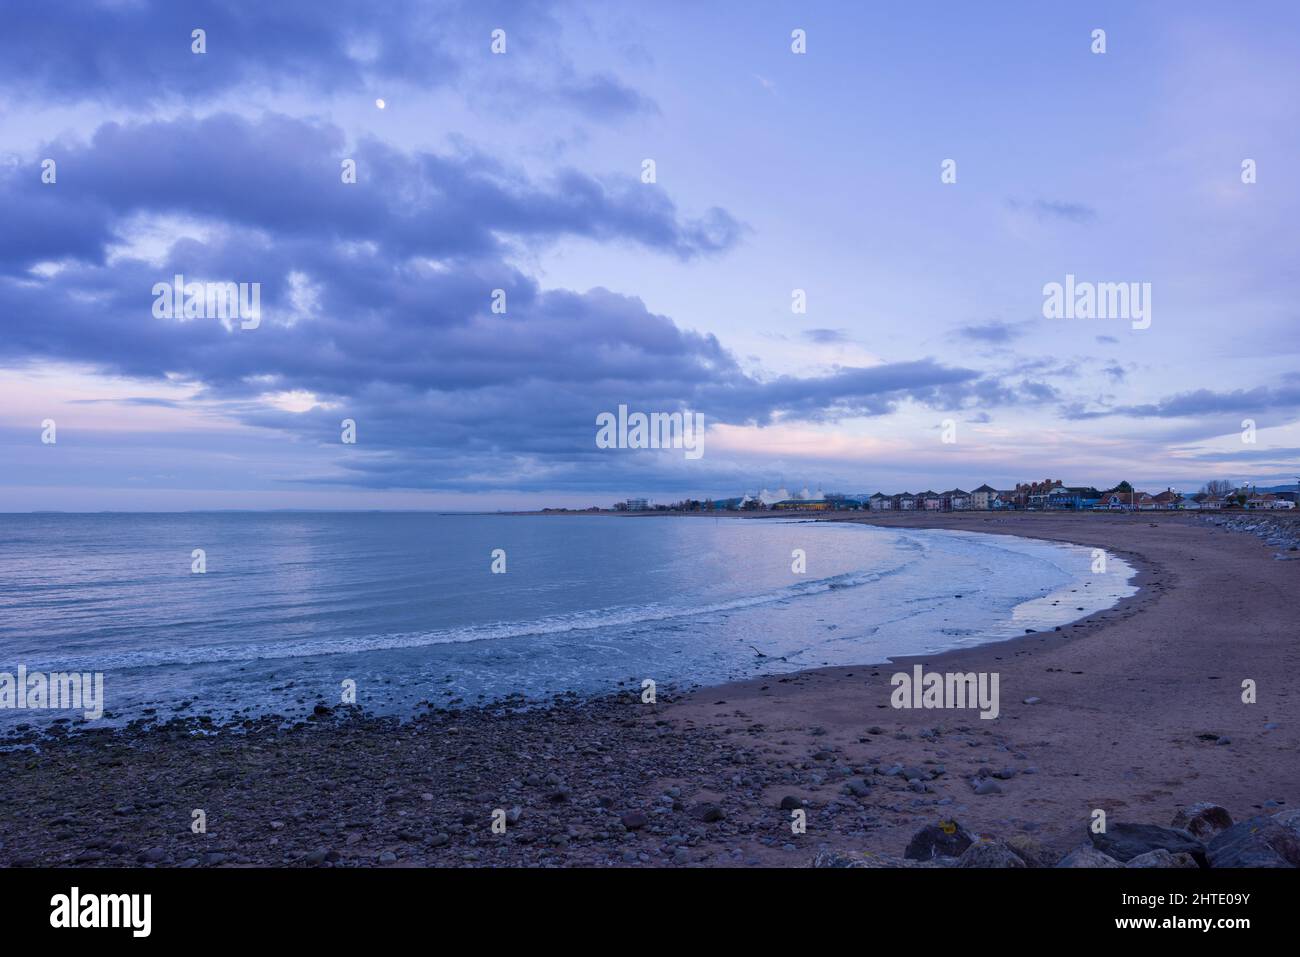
[0,116,1041,489]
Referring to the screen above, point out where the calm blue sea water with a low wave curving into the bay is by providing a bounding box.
[0,512,1134,728]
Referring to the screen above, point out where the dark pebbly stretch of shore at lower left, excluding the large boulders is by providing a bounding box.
[0,694,753,867]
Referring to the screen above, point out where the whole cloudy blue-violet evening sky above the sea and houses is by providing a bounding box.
[0,0,1300,511]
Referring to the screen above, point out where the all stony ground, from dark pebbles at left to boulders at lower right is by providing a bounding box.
[0,696,1300,867]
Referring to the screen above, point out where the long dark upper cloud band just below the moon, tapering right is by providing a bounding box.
[0,114,742,270]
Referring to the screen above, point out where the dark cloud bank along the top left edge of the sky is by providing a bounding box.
[0,0,657,118]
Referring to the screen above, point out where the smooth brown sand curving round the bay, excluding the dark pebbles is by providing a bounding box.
[671,512,1300,859]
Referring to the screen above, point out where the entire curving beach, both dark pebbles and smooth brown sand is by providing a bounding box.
[0,512,1300,866]
